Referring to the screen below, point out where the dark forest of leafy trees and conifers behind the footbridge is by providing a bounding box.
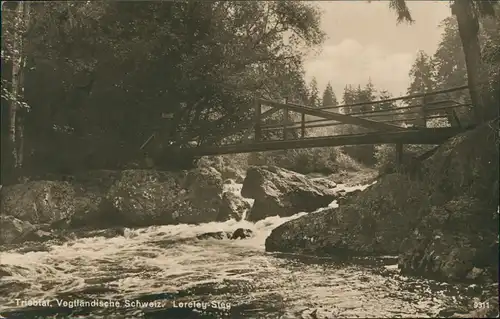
[1,1,500,184]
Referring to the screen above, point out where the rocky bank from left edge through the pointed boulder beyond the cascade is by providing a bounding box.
[0,160,344,245]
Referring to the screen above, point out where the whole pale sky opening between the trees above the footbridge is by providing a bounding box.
[305,0,451,101]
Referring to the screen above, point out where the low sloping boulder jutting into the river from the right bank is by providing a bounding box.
[266,174,426,256]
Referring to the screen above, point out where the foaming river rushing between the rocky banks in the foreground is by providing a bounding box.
[0,182,476,319]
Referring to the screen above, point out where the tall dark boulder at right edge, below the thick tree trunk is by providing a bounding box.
[399,121,499,281]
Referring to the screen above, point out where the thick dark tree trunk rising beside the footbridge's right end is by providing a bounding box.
[452,0,486,123]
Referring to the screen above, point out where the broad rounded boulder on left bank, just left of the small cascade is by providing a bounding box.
[72,168,227,227]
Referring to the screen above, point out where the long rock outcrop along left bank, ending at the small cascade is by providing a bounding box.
[1,167,249,243]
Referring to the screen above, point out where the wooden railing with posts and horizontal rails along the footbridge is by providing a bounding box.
[247,86,471,141]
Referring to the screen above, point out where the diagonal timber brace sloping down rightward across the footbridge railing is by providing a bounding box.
[258,99,408,131]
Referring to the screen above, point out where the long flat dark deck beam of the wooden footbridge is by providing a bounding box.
[184,127,464,156]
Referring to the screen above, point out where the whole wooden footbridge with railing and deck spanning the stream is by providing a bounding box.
[141,86,471,165]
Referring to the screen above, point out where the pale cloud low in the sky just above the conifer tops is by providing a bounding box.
[305,39,416,100]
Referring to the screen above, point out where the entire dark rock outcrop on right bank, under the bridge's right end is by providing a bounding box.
[266,123,499,280]
